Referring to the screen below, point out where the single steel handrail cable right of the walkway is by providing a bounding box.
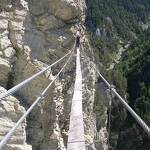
[92,64,150,136]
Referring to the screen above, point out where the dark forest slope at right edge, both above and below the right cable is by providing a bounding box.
[116,30,150,150]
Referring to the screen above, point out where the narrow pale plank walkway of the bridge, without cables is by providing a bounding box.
[67,48,85,150]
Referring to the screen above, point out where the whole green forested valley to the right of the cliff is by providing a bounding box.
[86,0,150,150]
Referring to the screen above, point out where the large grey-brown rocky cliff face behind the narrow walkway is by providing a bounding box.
[0,0,107,150]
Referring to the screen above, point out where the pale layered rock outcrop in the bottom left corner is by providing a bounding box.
[0,87,32,150]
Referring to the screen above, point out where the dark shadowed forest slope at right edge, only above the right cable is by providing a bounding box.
[118,30,150,125]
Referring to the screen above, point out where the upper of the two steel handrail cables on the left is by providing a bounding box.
[0,51,71,101]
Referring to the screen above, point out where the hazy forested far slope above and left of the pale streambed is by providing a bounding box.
[86,0,150,67]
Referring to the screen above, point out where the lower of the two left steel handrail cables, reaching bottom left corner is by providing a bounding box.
[0,49,74,150]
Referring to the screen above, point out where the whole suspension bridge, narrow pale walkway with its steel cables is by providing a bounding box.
[0,35,150,150]
